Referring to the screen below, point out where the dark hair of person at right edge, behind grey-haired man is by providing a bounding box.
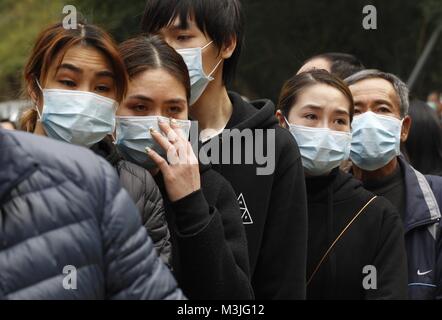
[405,100,442,175]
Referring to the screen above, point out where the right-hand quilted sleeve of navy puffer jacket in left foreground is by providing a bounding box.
[101,160,184,300]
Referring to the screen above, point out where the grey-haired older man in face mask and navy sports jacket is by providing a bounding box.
[346,70,442,299]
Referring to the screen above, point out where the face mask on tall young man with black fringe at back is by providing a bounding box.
[177,41,223,106]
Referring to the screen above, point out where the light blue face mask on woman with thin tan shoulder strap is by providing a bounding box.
[286,119,351,176]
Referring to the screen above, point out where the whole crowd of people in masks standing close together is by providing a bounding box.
[0,0,442,300]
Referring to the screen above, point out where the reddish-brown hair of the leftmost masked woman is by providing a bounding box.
[20,22,128,132]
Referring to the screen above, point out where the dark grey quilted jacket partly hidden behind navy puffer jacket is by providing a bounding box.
[91,138,172,266]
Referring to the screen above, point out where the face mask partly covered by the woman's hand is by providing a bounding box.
[116,116,191,170]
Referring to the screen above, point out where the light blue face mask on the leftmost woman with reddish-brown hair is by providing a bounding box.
[37,89,117,148]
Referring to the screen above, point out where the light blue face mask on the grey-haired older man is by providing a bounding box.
[350,111,402,171]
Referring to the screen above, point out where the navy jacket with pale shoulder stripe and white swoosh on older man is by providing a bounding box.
[399,157,442,300]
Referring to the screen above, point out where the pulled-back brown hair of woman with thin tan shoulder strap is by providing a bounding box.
[277,69,354,122]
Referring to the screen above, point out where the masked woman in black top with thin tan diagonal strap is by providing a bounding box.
[277,70,407,300]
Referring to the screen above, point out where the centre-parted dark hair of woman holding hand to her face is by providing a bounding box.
[120,36,190,100]
